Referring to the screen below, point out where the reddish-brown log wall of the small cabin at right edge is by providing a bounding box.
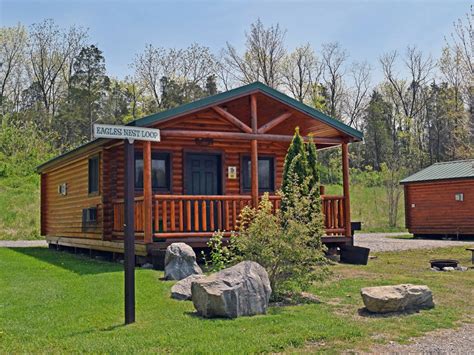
[405,179,474,234]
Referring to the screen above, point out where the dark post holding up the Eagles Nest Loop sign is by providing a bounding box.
[123,140,135,324]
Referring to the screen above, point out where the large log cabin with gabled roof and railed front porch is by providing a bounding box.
[38,82,362,257]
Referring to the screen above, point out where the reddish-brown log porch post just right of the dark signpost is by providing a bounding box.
[143,141,153,243]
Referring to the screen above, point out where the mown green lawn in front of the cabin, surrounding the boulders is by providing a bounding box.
[0,247,474,353]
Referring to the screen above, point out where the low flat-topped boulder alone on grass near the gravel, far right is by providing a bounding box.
[360,284,434,313]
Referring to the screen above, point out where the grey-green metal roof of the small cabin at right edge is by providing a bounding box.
[400,159,474,184]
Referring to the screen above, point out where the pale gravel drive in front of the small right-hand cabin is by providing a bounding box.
[354,232,474,251]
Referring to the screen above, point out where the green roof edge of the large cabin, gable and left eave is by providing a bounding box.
[37,81,363,172]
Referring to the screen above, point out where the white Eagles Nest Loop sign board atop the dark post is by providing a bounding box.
[94,124,160,143]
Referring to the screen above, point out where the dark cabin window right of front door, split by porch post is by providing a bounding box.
[242,156,275,192]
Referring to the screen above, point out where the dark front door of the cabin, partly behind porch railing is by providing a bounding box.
[184,153,222,232]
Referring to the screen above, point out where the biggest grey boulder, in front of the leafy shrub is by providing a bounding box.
[191,261,272,318]
